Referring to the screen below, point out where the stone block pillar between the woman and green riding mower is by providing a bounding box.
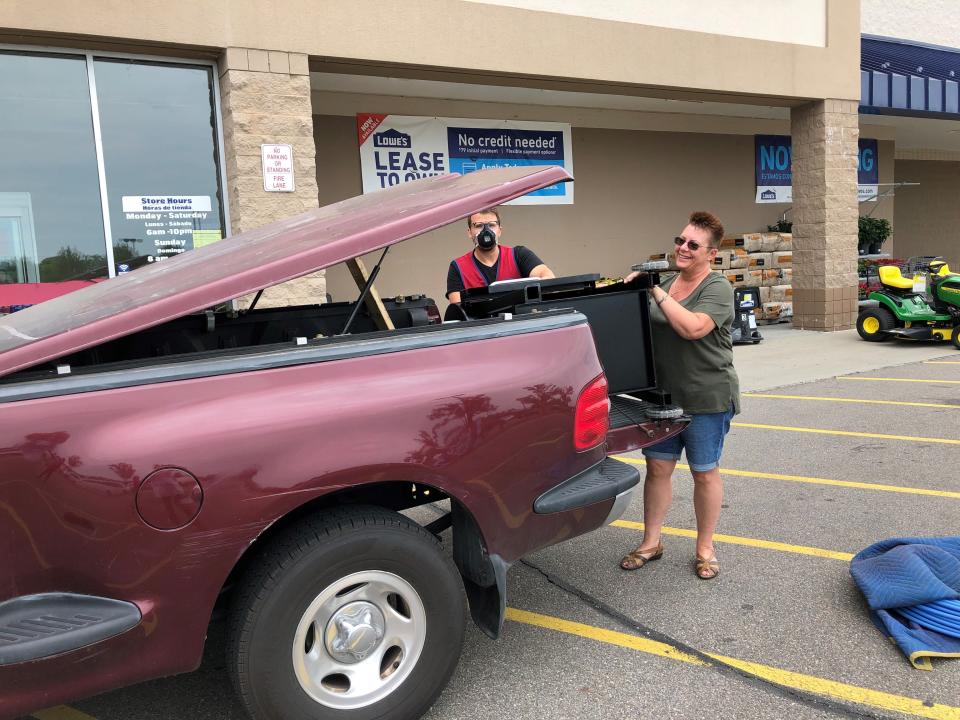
[790,100,860,330]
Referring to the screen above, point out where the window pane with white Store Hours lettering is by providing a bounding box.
[94,59,223,270]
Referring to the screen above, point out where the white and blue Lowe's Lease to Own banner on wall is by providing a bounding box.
[357,113,573,205]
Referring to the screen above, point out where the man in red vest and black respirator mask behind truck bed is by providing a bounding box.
[447,208,556,303]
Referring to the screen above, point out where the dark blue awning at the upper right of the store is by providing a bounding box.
[860,35,960,119]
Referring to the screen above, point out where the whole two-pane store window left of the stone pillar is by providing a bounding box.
[0,51,225,306]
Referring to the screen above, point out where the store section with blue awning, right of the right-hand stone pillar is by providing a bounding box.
[860,0,960,267]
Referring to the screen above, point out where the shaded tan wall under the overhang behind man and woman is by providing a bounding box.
[314,114,893,305]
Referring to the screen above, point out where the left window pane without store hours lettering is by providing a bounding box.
[0,53,106,284]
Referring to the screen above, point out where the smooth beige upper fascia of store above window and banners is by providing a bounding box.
[0,0,860,100]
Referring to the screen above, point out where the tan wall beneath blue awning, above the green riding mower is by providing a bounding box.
[893,160,960,268]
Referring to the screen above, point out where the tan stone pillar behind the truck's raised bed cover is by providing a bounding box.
[220,48,326,307]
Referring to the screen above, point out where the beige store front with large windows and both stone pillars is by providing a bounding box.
[0,0,872,330]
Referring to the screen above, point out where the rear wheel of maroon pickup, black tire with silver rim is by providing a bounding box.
[227,506,465,720]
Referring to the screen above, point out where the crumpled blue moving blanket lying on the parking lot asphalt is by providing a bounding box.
[850,537,960,670]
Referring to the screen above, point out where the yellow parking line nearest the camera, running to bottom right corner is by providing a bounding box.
[507,607,960,720]
